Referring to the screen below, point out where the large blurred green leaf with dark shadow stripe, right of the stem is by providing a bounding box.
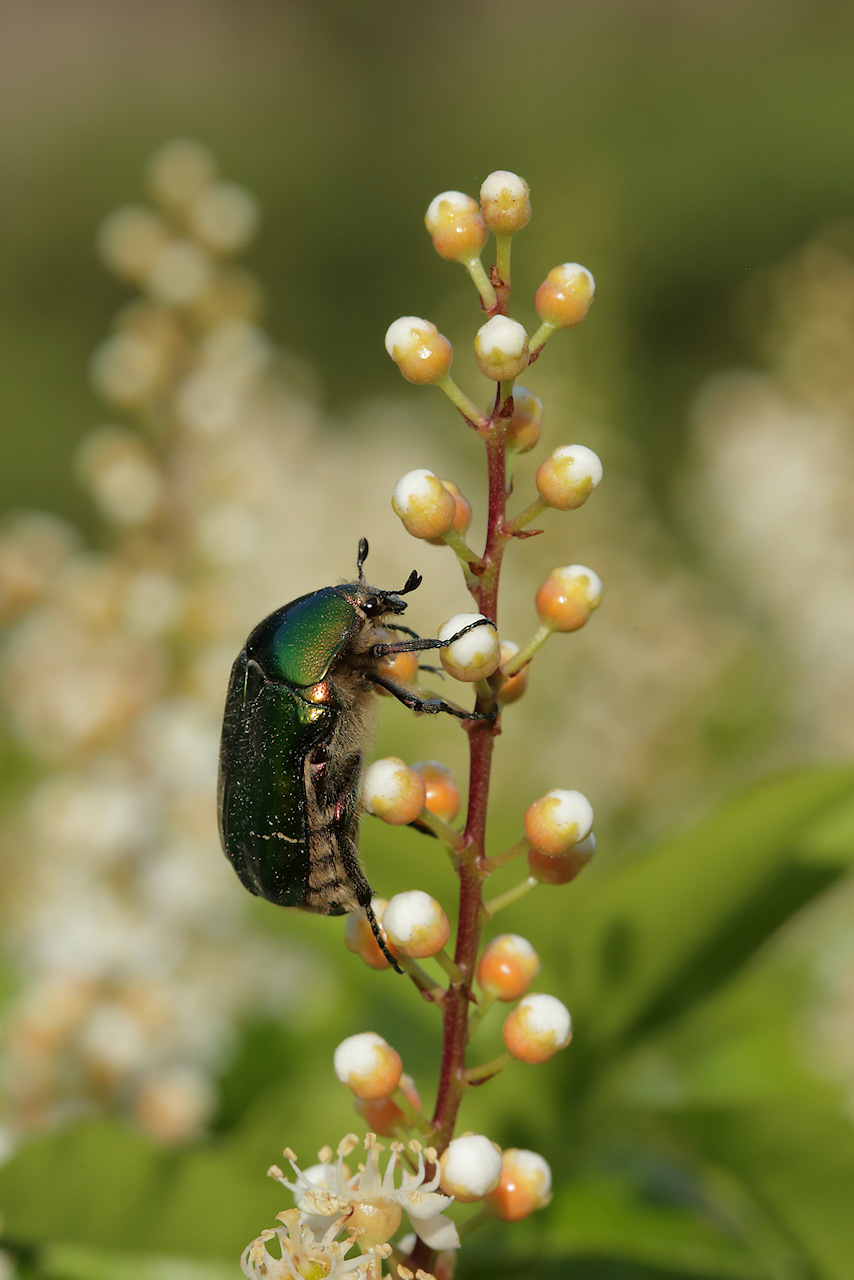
[563,769,854,1051]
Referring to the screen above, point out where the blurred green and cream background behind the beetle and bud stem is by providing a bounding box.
[0,0,854,1280]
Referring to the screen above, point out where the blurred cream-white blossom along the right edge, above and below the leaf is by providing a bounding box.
[689,232,854,1115]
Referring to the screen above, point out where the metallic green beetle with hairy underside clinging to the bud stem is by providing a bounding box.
[218,538,495,973]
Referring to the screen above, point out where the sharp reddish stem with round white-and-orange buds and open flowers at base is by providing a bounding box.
[245,170,602,1280]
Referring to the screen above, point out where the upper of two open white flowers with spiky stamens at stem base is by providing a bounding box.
[268,1133,460,1249]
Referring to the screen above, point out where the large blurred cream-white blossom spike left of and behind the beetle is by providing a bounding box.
[0,142,460,1143]
